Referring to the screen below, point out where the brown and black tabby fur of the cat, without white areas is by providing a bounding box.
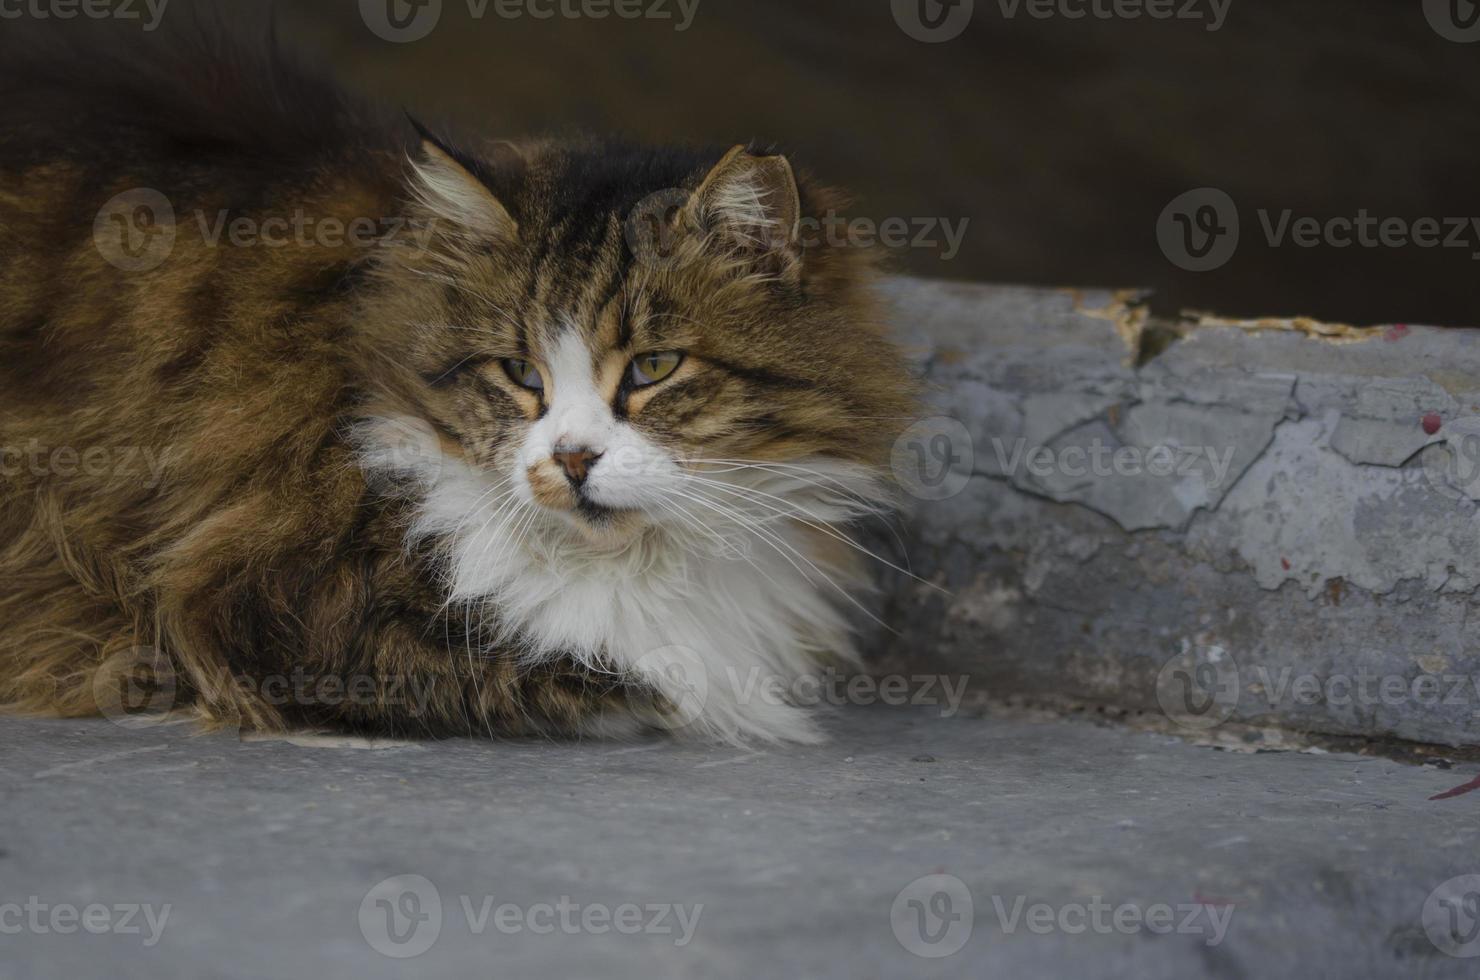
[0,15,910,733]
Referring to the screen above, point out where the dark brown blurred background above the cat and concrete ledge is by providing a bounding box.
[275,0,1480,326]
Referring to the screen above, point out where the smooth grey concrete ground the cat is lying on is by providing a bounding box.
[0,708,1480,980]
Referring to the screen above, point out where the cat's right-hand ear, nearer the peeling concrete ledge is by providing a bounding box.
[693,147,802,268]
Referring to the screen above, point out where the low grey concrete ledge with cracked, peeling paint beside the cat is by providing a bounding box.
[876,280,1480,746]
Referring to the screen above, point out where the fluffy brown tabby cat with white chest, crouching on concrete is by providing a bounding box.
[0,17,916,742]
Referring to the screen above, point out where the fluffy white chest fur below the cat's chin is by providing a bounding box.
[361,419,878,740]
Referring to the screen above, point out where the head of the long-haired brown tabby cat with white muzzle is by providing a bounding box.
[356,138,912,545]
